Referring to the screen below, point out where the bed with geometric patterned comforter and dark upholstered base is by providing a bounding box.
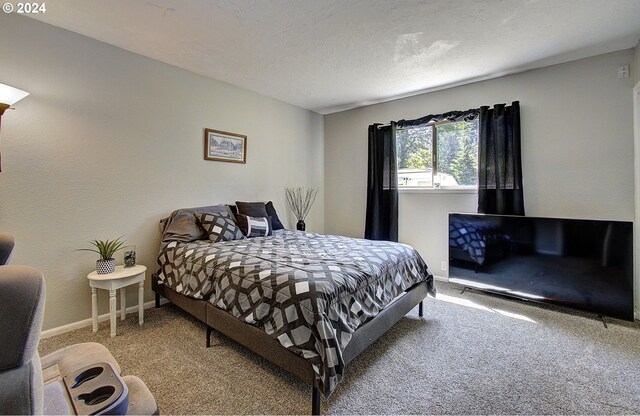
[152,205,435,414]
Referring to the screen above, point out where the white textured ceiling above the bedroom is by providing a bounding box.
[25,0,640,114]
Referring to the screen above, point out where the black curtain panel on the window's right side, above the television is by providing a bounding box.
[478,101,524,215]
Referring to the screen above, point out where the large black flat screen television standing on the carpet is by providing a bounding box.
[449,213,633,321]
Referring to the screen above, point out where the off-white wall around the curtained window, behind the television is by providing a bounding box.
[324,50,634,276]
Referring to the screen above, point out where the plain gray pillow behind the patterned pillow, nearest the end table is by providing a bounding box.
[161,204,233,243]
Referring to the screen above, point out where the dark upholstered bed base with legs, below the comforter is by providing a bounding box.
[152,279,427,415]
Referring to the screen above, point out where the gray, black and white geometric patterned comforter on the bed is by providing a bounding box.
[158,230,435,397]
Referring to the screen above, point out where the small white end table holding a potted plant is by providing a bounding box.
[87,264,147,337]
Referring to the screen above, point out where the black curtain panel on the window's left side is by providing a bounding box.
[364,122,398,241]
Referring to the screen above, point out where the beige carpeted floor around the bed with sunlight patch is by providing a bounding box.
[40,282,640,414]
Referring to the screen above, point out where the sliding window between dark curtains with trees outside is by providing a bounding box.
[396,119,478,188]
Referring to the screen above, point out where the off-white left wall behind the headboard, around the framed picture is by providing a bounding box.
[0,13,324,329]
